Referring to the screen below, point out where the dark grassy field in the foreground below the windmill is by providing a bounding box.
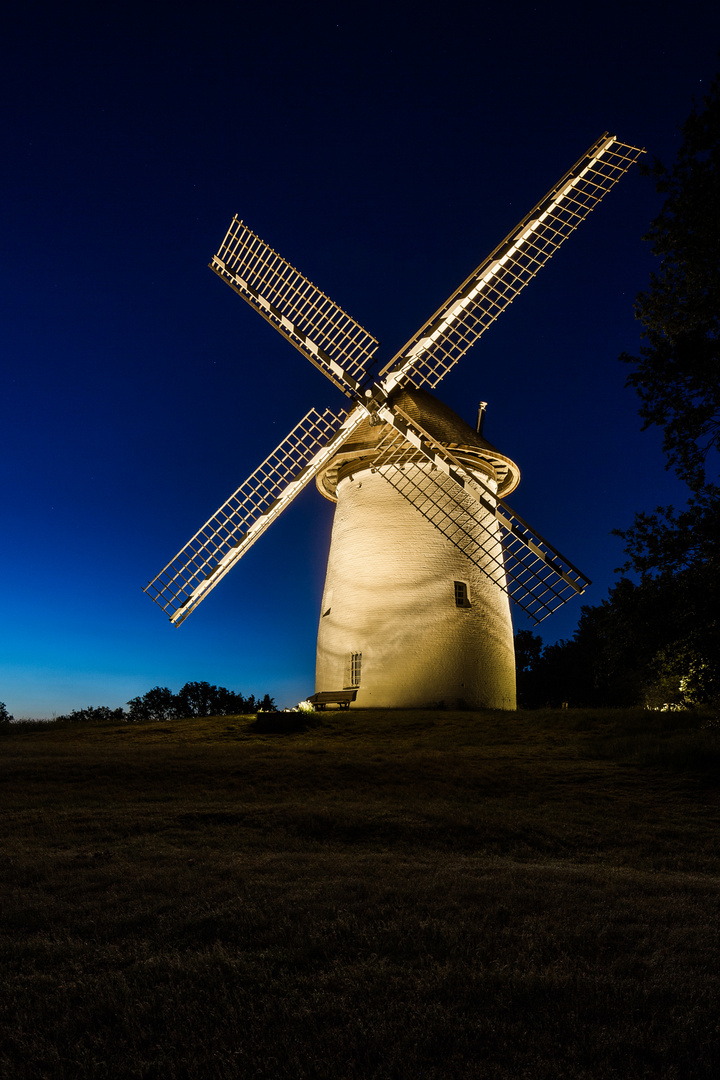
[0,711,720,1080]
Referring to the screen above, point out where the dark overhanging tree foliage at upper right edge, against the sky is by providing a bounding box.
[621,78,720,490]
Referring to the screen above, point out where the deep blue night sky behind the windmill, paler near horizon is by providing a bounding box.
[0,0,720,716]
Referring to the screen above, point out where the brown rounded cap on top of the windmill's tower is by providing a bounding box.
[316,387,520,502]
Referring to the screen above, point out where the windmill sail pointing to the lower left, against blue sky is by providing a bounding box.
[144,408,367,626]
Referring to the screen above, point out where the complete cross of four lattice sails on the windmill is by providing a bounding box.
[145,132,644,625]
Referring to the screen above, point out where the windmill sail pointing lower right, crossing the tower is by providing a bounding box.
[373,406,590,623]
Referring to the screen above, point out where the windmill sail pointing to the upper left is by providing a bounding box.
[209,216,379,397]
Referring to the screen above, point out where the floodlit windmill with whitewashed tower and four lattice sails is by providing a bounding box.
[145,133,643,708]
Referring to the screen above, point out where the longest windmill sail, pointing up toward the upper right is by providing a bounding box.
[380,132,644,393]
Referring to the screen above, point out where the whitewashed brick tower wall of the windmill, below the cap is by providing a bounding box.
[315,467,515,708]
